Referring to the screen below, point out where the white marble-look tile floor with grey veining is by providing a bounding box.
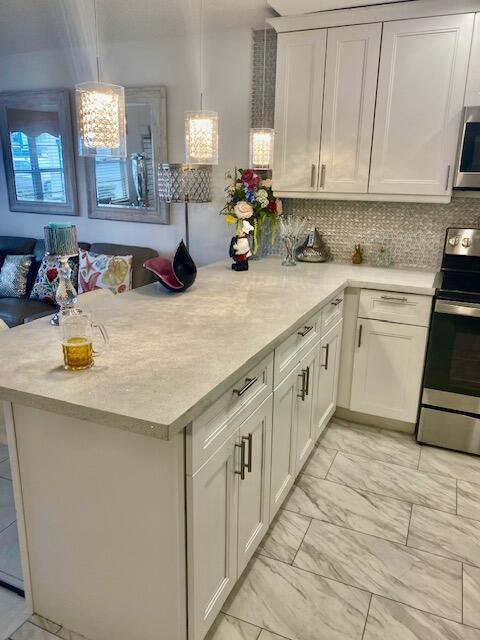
[0,420,480,640]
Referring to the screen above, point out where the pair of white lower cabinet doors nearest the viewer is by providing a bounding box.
[187,394,272,640]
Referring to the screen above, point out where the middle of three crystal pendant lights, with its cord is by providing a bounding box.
[185,0,218,165]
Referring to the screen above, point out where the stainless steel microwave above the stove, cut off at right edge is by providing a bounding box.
[454,107,480,191]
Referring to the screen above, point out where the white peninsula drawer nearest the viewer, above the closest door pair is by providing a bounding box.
[186,353,273,475]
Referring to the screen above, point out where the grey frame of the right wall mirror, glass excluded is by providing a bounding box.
[85,87,170,224]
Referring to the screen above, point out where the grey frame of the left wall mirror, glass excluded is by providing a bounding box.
[0,89,80,216]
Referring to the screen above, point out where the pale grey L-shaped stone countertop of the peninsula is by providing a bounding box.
[0,258,435,439]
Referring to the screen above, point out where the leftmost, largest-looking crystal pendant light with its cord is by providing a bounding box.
[75,0,127,158]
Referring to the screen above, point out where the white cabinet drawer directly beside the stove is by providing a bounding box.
[358,289,432,327]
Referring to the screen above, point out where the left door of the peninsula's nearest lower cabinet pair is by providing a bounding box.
[187,431,240,640]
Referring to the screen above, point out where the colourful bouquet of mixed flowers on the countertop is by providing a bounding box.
[220,169,283,254]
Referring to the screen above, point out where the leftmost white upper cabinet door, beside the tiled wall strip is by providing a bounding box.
[273,29,327,191]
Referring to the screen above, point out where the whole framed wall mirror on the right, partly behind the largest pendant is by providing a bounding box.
[87,87,170,224]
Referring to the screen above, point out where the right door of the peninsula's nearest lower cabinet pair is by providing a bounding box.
[238,395,273,575]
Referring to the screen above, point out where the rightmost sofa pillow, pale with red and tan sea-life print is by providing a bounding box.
[78,251,133,293]
